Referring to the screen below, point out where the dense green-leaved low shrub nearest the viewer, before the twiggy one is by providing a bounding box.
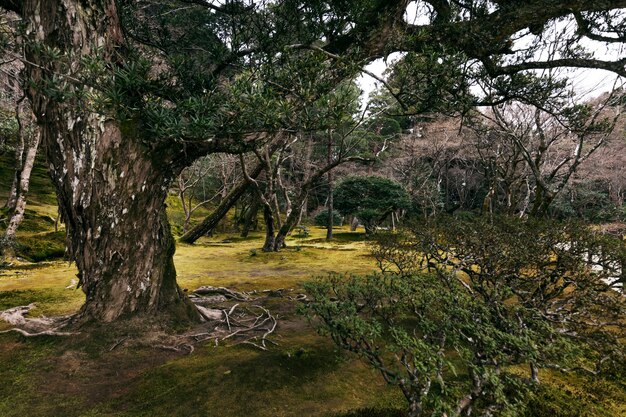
[303,274,540,416]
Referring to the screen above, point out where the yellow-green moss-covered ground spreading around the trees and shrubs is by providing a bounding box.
[0,161,626,417]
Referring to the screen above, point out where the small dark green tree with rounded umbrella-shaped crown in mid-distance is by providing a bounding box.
[334,176,411,234]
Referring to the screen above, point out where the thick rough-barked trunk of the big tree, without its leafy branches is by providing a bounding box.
[22,0,199,322]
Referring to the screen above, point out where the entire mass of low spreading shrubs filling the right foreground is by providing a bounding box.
[303,218,626,416]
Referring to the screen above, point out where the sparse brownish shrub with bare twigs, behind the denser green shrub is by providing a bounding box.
[374,217,626,372]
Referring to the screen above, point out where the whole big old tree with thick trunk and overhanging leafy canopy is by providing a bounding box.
[0,0,626,321]
